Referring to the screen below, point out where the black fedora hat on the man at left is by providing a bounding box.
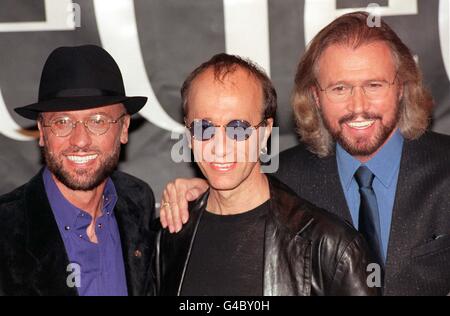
[14,45,147,120]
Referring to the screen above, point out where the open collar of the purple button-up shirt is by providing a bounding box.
[43,167,117,232]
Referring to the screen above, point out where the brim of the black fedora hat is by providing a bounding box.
[14,96,147,120]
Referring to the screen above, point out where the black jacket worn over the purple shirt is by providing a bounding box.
[0,171,155,295]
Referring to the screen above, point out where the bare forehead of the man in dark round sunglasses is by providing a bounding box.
[188,68,263,118]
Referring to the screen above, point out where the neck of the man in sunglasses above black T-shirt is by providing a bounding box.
[207,164,270,215]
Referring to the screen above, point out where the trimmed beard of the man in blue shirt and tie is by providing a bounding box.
[322,109,400,156]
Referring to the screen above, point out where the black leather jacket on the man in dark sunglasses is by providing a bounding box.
[153,177,379,296]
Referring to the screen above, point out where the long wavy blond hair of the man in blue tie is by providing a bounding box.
[292,12,433,157]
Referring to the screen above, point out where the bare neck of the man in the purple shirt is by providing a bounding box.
[52,174,106,221]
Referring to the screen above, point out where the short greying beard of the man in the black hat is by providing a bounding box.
[42,141,120,191]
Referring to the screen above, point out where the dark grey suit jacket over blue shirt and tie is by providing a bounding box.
[277,132,450,295]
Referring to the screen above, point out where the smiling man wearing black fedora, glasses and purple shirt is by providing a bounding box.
[0,45,154,296]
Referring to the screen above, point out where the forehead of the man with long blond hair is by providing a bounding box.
[318,41,396,81]
